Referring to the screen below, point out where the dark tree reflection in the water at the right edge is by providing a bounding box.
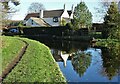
[102,44,120,80]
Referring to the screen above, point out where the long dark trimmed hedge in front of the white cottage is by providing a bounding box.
[23,26,68,36]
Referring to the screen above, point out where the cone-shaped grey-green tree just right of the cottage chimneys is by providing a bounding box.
[73,2,92,29]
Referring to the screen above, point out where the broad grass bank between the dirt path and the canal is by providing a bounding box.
[1,37,66,82]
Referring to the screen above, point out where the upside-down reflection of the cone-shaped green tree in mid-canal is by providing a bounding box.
[72,51,91,77]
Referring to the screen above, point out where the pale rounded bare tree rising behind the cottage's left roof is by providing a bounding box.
[28,2,45,13]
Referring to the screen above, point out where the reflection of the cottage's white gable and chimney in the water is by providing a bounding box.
[51,49,72,66]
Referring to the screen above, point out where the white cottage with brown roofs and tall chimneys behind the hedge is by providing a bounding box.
[24,5,74,26]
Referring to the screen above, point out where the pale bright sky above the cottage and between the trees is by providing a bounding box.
[9,0,119,23]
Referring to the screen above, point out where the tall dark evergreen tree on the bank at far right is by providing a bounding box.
[102,2,119,38]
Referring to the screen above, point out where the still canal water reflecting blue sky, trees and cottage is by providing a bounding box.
[28,39,120,84]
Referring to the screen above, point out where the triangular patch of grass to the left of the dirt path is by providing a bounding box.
[0,36,25,75]
